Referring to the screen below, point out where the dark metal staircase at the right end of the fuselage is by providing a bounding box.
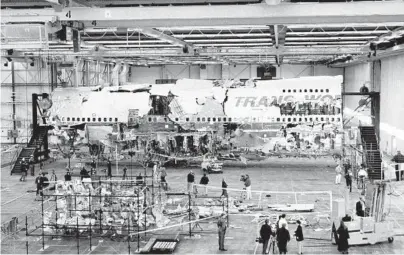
[359,126,382,180]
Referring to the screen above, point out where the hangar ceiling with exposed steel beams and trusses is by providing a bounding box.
[2,0,404,65]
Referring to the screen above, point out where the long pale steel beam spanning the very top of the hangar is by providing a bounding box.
[1,1,404,27]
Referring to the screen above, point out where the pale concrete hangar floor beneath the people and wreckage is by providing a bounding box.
[1,158,404,254]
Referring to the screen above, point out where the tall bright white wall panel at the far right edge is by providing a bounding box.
[380,55,404,154]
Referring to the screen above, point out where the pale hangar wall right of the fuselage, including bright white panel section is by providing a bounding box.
[344,55,404,155]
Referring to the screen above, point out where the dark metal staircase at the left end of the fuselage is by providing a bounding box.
[11,126,48,174]
